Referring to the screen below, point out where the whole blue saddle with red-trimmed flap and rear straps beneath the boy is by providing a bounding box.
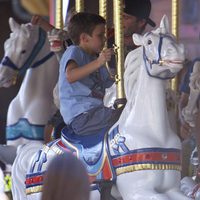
[26,126,115,193]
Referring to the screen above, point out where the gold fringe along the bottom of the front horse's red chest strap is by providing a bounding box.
[116,164,181,175]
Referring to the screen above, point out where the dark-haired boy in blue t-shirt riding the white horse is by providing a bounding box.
[59,12,122,135]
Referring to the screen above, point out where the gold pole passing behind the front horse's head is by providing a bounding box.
[171,0,180,91]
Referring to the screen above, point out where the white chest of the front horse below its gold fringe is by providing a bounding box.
[117,170,189,200]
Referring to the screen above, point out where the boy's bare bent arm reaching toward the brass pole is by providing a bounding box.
[66,49,113,83]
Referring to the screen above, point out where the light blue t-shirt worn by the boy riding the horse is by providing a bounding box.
[58,45,113,124]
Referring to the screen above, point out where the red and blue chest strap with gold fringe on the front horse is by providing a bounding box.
[112,148,181,175]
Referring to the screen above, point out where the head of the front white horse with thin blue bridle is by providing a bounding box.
[133,16,185,79]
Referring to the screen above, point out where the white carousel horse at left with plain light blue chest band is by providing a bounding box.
[0,18,59,146]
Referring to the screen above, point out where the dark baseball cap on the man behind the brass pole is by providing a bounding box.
[124,0,156,27]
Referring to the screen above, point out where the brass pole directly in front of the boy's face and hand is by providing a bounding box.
[113,0,125,102]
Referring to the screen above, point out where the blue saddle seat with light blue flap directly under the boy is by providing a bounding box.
[61,127,107,169]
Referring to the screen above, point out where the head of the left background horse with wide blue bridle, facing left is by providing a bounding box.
[0,18,50,87]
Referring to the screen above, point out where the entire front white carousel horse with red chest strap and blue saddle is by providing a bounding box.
[13,16,190,200]
